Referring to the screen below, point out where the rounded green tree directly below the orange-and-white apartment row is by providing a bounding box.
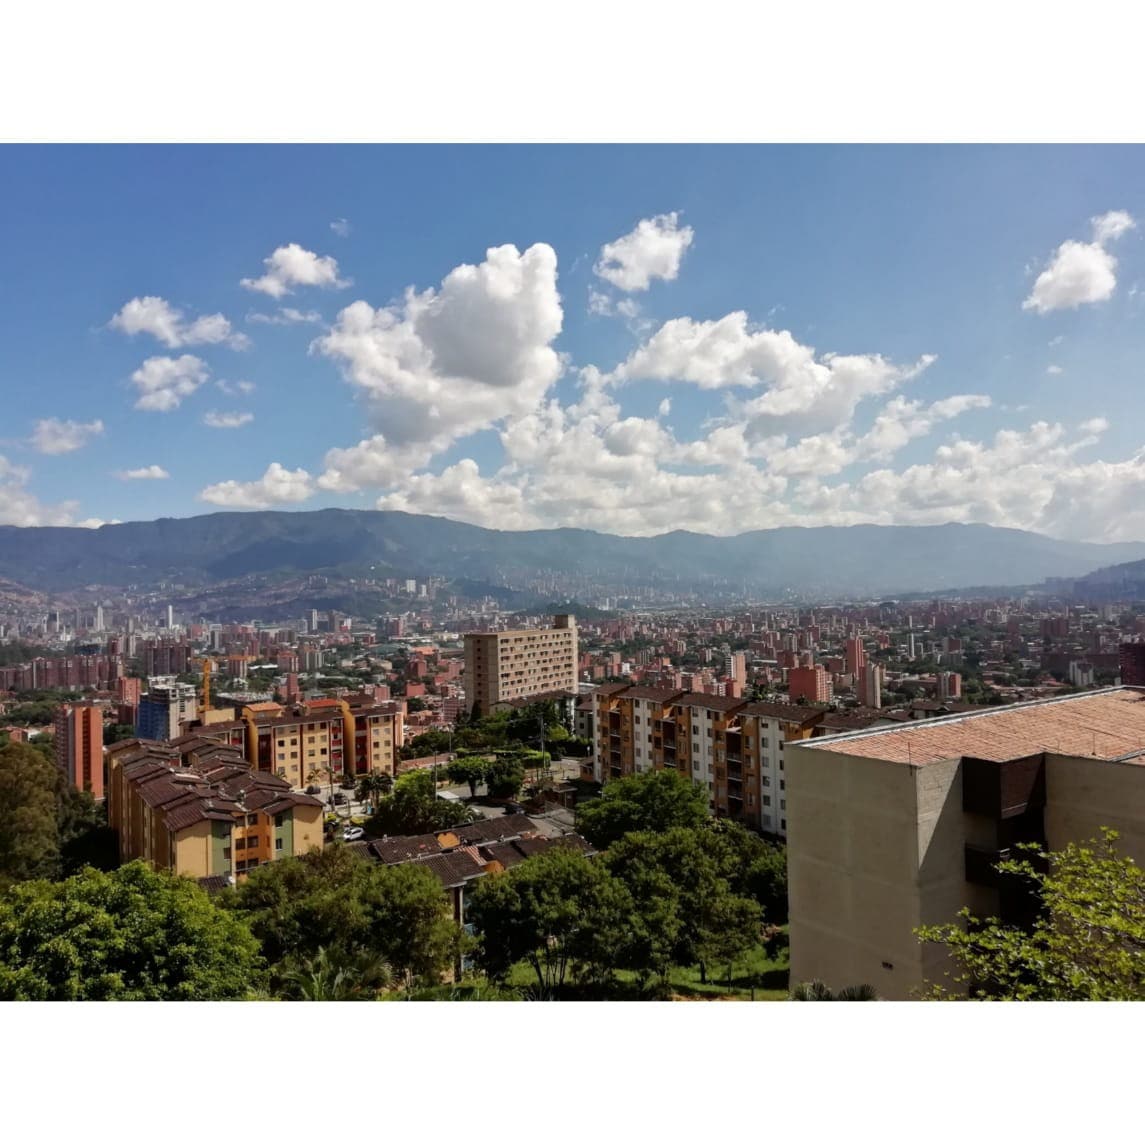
[577,769,708,848]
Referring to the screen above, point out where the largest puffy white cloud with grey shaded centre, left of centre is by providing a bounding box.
[311,244,564,478]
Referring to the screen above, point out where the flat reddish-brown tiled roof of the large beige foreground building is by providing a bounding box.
[800,688,1145,765]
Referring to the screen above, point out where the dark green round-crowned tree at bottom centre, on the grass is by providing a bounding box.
[469,847,632,994]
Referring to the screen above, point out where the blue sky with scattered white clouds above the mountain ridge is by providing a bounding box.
[0,144,1145,540]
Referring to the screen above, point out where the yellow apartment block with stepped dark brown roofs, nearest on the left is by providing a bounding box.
[108,735,323,882]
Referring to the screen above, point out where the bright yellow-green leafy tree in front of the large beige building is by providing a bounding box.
[918,828,1145,1002]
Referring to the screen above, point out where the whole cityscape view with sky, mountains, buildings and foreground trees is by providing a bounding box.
[0,145,1145,1014]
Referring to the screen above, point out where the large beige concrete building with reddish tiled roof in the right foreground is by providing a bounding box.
[785,687,1145,1000]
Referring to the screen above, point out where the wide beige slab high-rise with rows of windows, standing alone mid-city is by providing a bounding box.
[465,615,577,716]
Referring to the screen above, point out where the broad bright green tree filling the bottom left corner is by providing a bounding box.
[0,862,262,1002]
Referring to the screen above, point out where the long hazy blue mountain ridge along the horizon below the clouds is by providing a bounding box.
[0,510,1145,595]
